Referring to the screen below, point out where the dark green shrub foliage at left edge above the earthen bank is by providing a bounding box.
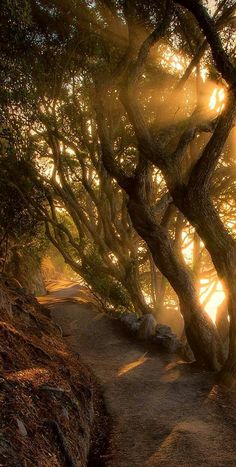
[0,137,48,294]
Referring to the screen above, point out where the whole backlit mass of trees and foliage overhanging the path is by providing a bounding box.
[0,0,236,382]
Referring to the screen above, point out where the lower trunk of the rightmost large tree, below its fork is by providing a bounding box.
[174,187,236,385]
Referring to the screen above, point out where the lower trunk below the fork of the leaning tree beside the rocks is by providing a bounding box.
[128,198,224,370]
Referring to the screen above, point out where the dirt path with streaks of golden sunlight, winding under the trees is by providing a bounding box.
[41,284,236,467]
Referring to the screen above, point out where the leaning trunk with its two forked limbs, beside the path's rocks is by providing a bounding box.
[95,89,224,369]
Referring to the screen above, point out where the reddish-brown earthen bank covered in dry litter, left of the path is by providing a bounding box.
[0,281,107,467]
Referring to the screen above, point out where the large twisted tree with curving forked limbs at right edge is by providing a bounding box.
[95,1,236,379]
